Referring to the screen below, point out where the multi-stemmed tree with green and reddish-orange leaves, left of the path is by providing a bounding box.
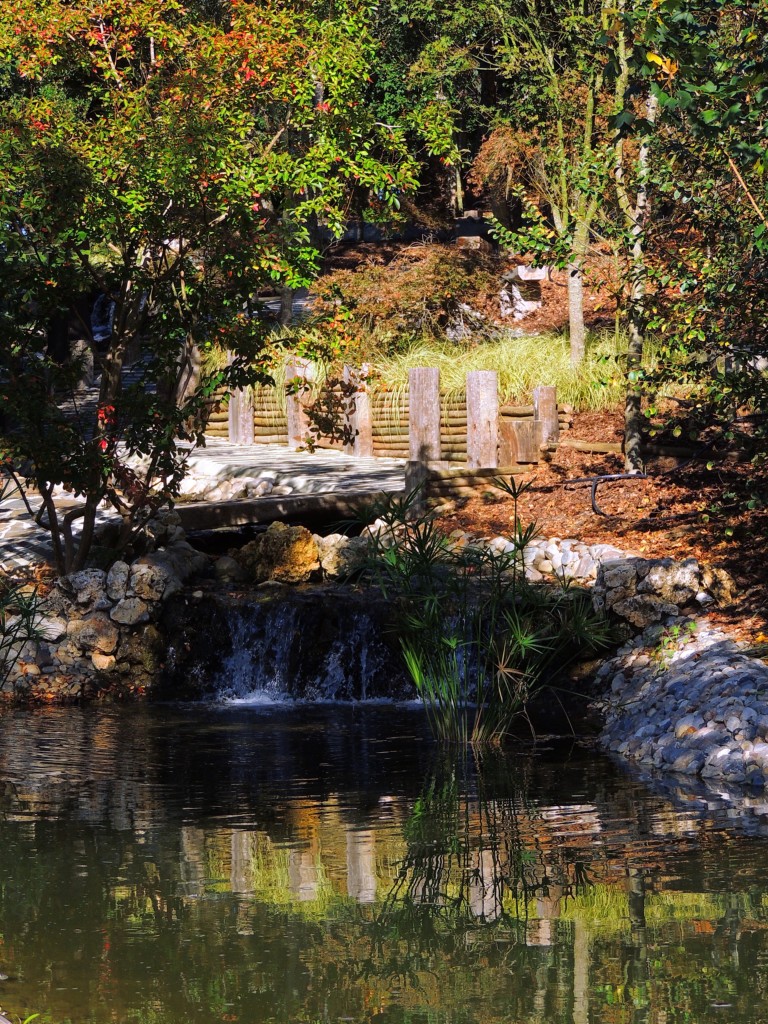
[0,0,423,571]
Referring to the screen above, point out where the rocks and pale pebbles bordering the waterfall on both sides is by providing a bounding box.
[6,505,757,770]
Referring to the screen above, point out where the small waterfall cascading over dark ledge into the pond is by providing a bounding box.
[161,587,414,703]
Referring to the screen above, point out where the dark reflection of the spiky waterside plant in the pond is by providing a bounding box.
[368,755,589,985]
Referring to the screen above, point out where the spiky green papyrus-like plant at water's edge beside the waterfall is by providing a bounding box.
[371,479,612,746]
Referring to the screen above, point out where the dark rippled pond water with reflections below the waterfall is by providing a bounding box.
[0,706,768,1024]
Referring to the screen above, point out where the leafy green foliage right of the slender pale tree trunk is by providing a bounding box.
[622,0,768,475]
